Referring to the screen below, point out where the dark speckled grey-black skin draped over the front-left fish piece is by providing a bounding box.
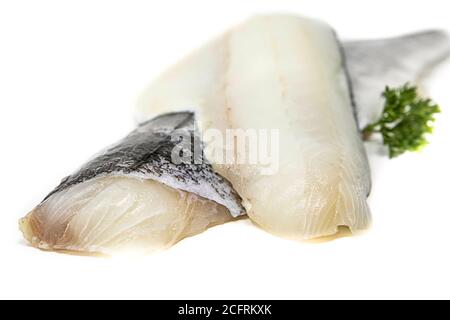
[44,112,245,216]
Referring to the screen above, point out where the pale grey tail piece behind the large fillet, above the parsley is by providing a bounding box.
[342,30,450,129]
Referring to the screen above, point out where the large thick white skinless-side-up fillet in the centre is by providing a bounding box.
[139,15,370,239]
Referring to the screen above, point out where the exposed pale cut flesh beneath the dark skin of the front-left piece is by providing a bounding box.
[19,177,234,256]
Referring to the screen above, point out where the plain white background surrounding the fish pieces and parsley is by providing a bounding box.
[0,0,450,299]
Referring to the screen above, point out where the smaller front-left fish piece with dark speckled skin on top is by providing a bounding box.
[20,112,244,255]
